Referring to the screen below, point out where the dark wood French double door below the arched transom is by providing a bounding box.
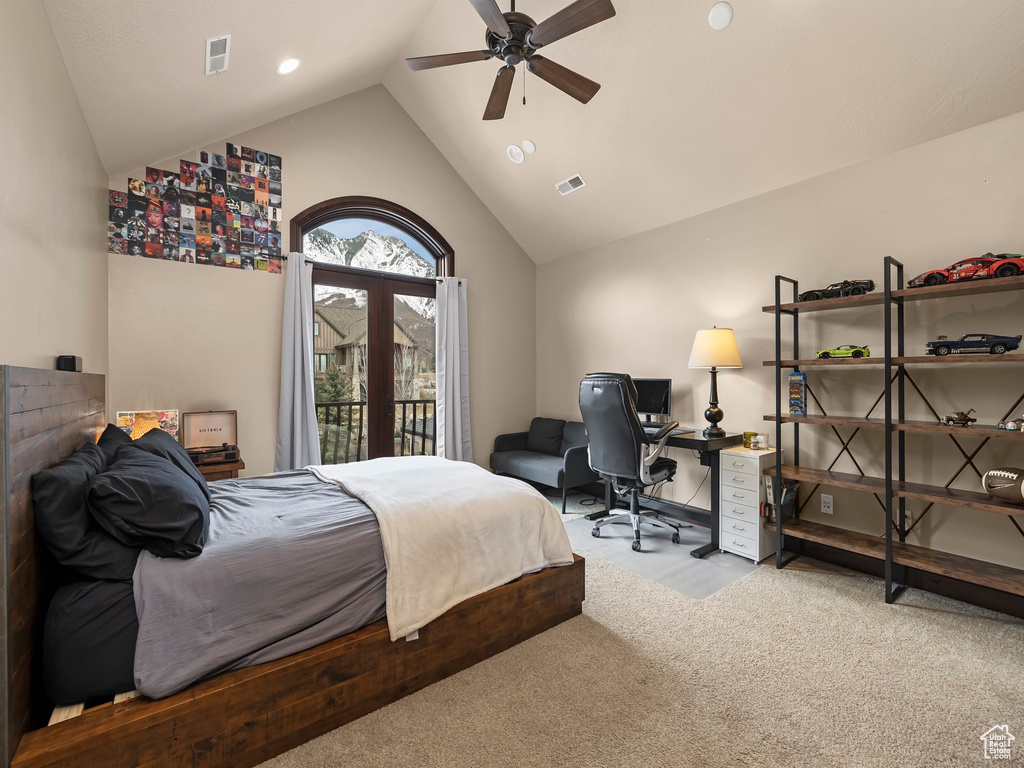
[312,265,436,464]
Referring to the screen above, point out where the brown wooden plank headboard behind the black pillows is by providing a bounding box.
[0,366,106,766]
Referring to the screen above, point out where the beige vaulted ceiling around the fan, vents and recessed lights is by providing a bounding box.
[44,0,1024,262]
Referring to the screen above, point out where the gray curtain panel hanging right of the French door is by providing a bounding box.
[436,278,473,462]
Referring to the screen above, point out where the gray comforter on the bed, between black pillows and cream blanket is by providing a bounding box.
[134,471,386,698]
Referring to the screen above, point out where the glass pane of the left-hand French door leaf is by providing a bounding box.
[313,285,370,464]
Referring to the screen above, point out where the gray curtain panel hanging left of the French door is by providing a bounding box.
[273,253,321,472]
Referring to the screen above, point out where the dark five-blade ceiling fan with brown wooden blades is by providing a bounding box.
[406,0,615,120]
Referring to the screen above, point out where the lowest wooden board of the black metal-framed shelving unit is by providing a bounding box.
[765,520,1024,595]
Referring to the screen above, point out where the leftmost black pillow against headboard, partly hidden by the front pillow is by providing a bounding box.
[32,442,139,581]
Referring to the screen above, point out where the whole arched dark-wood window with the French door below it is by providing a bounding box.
[291,197,455,464]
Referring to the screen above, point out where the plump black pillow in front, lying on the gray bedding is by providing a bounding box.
[86,440,210,558]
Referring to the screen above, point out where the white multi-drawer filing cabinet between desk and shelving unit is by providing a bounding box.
[719,445,776,562]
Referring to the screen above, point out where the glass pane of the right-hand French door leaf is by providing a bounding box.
[394,295,437,456]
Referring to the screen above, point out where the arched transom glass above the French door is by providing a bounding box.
[302,218,437,278]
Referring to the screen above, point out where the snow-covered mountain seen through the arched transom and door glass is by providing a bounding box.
[302,228,434,324]
